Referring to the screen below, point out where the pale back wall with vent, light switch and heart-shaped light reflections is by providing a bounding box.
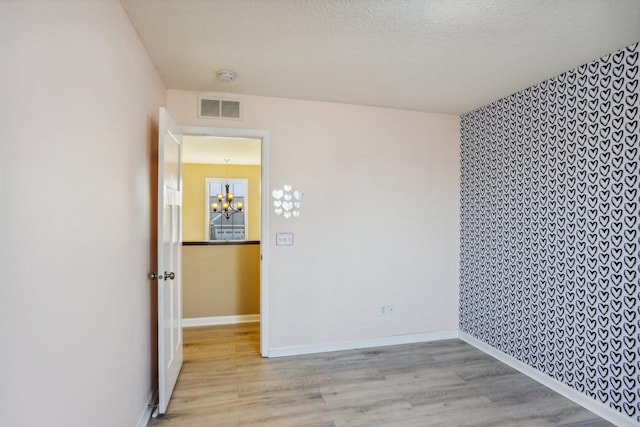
[167,90,459,349]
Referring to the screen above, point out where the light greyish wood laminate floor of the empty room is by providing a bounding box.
[149,323,611,427]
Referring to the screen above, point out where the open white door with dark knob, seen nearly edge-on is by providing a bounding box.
[157,108,182,414]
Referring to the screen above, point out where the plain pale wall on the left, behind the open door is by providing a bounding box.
[0,0,166,427]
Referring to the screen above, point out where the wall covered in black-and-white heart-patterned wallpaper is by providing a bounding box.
[460,43,640,422]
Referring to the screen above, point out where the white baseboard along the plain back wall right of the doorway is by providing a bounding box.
[269,331,458,357]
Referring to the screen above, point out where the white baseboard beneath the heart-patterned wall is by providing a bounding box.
[459,331,640,427]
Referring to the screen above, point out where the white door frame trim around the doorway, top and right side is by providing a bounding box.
[180,126,270,357]
